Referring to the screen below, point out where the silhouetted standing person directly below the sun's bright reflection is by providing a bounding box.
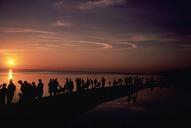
[7,80,16,104]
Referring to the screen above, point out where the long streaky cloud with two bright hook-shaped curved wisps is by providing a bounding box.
[34,35,138,50]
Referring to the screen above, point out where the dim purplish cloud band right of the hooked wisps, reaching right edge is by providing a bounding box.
[118,32,191,52]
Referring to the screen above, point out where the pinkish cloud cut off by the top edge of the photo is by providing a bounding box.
[78,0,126,10]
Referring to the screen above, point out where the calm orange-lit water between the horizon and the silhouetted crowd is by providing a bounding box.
[0,70,158,102]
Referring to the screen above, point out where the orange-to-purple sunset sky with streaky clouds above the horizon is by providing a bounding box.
[0,0,191,72]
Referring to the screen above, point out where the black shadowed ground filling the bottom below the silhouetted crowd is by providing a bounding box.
[1,87,191,128]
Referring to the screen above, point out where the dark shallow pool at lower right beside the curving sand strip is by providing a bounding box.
[71,88,191,128]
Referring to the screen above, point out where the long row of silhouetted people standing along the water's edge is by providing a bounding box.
[0,76,157,104]
